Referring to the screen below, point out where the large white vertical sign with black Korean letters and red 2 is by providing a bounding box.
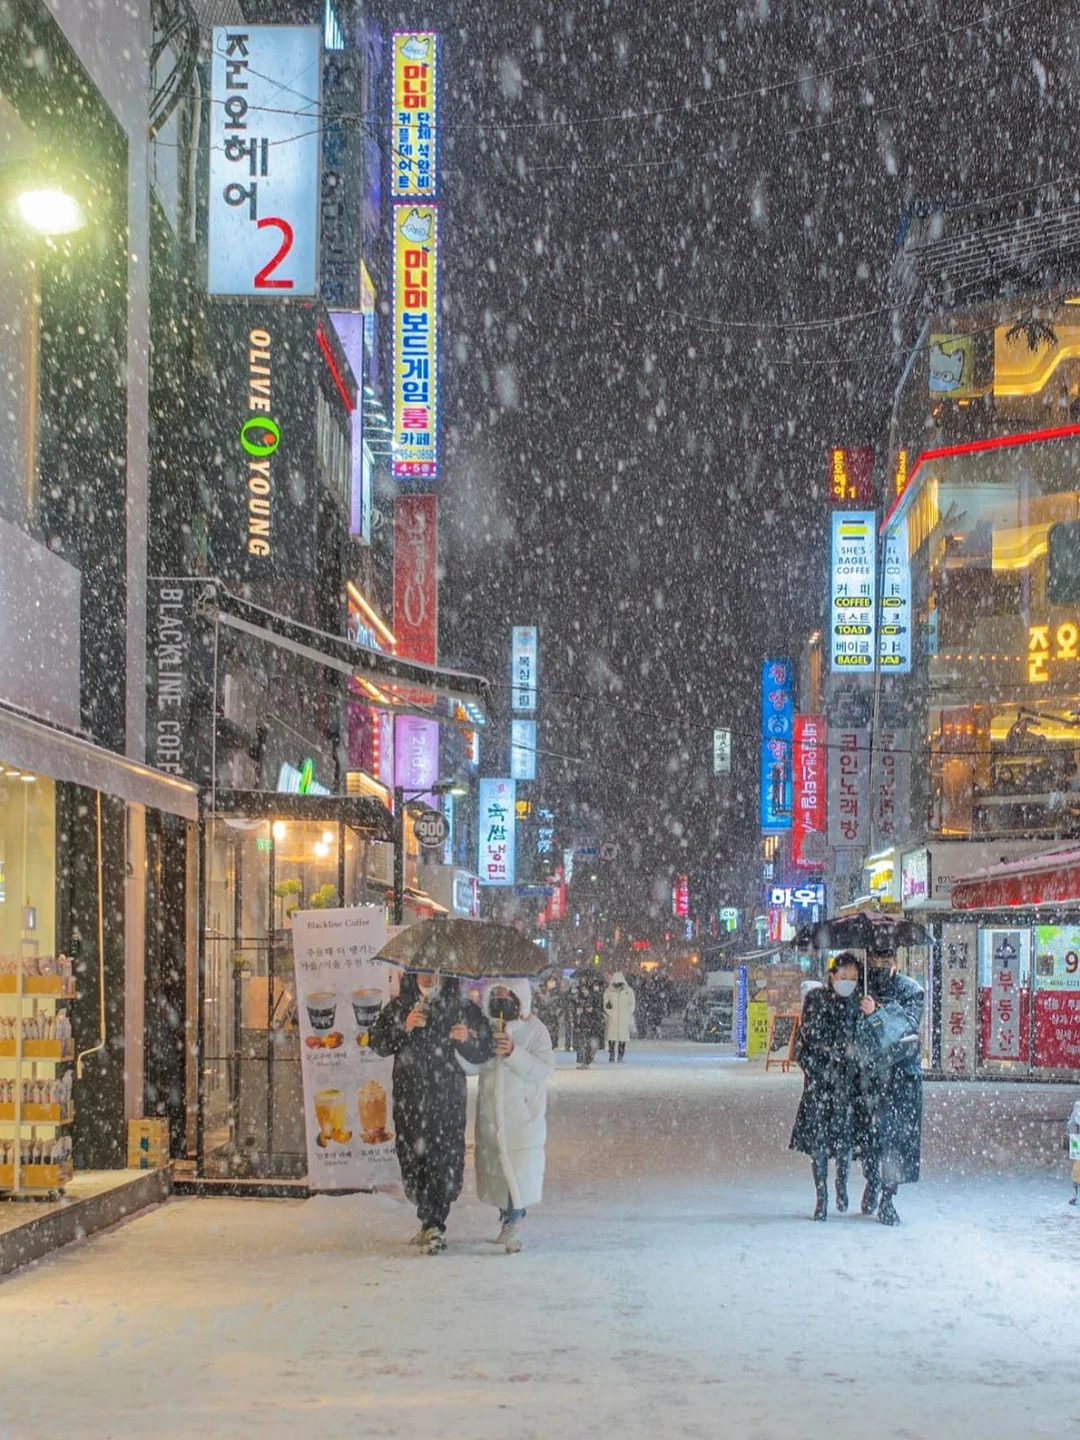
[206,24,323,298]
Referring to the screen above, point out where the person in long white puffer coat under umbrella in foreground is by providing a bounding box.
[477,981,554,1254]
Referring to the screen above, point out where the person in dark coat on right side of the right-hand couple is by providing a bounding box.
[854,958,926,1225]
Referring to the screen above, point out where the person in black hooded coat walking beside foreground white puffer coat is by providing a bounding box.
[370,975,495,1254]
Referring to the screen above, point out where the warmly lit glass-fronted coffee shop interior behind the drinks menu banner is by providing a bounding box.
[197,792,393,1179]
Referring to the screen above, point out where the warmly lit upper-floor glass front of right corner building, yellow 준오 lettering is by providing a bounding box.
[888,327,1080,837]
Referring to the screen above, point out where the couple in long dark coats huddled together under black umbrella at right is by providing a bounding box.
[791,950,923,1225]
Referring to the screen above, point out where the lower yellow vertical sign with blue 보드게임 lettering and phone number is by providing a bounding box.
[392,203,439,480]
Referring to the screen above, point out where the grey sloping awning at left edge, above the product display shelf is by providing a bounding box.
[0,704,199,819]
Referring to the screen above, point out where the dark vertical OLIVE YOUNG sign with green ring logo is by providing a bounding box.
[207,302,321,580]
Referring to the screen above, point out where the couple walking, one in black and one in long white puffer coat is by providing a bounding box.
[372,975,554,1254]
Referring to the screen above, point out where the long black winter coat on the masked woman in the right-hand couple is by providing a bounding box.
[791,986,858,1156]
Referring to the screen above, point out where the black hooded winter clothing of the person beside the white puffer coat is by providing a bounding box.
[370,975,495,1200]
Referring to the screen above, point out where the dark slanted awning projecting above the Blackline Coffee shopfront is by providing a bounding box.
[200,582,488,727]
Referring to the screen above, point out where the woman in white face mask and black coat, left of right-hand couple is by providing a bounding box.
[791,950,860,1220]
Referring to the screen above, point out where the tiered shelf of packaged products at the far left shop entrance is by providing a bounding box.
[0,960,75,1198]
